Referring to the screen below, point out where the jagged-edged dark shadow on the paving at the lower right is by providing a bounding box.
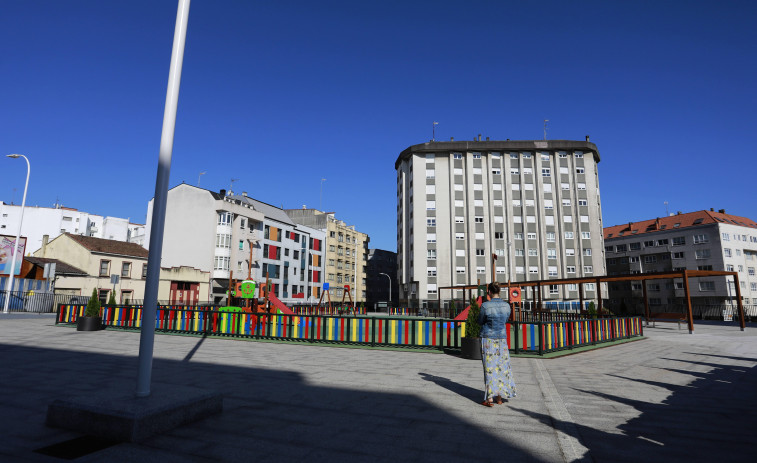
[512,356,757,463]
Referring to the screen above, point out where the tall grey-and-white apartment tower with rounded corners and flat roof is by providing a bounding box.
[395,137,605,306]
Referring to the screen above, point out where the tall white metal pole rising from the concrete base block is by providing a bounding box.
[136,0,190,397]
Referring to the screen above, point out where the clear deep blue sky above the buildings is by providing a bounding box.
[0,0,757,250]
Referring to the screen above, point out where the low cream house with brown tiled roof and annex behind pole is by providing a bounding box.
[31,233,208,305]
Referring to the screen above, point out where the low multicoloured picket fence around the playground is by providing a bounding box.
[56,305,643,354]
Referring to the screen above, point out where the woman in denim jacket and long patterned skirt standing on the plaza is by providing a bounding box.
[478,282,515,407]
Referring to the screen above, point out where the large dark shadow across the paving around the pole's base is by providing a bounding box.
[0,340,547,462]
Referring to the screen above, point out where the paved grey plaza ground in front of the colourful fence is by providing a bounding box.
[0,314,757,463]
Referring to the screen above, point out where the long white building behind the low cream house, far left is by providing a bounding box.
[0,201,146,253]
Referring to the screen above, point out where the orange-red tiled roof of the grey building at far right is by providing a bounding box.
[603,209,757,239]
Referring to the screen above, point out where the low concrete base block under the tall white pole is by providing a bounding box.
[47,384,223,442]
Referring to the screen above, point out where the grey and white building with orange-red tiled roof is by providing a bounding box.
[604,209,757,306]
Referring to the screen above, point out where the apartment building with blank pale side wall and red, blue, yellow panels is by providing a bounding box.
[146,184,326,304]
